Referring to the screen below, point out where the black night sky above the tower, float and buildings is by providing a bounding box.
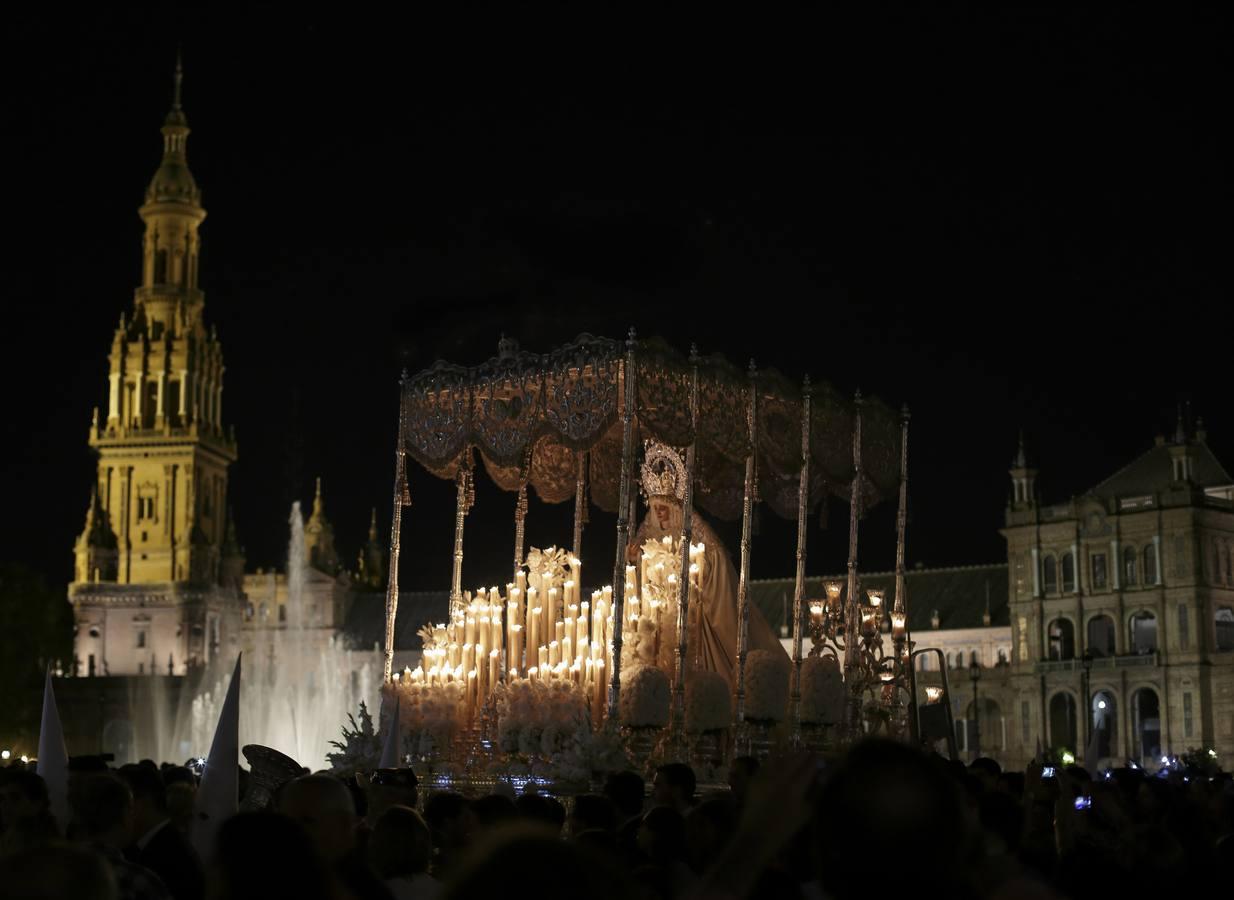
[0,4,1234,597]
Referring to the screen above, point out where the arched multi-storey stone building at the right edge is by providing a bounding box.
[1002,416,1234,768]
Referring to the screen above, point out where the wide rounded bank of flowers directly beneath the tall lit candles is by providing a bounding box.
[494,679,591,759]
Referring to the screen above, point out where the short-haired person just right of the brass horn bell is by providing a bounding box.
[279,775,390,900]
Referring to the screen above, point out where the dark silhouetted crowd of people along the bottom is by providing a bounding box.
[0,741,1234,900]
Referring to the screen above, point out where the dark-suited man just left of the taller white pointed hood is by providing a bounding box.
[118,764,206,900]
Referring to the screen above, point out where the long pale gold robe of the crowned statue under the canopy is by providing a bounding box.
[634,512,787,689]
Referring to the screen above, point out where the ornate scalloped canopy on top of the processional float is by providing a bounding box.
[401,335,901,520]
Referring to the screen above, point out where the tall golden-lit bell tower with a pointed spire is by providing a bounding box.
[69,60,236,674]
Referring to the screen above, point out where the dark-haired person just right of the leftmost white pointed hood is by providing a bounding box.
[69,772,172,900]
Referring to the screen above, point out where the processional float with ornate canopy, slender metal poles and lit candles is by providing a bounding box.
[384,330,937,780]
